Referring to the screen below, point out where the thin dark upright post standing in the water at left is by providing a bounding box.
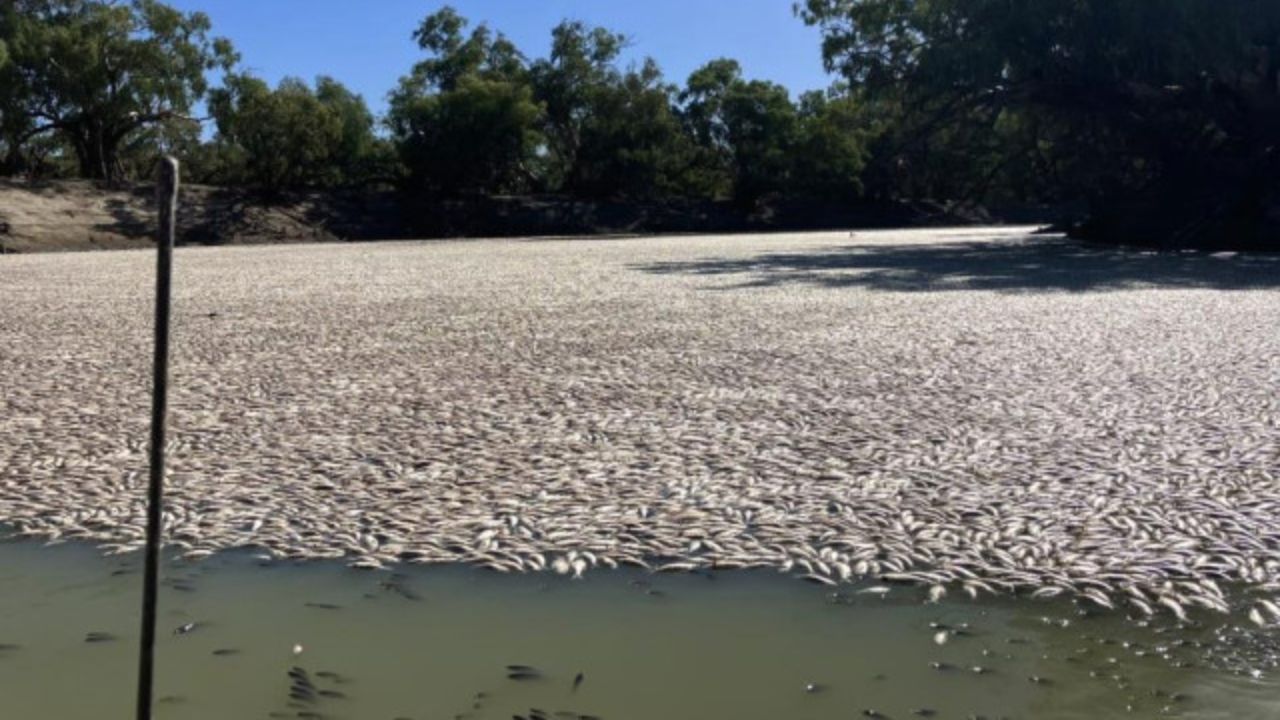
[138,158,178,720]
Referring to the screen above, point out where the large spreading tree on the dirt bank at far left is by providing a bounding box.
[0,0,236,179]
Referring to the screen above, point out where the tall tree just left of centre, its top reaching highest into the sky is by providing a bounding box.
[387,8,541,195]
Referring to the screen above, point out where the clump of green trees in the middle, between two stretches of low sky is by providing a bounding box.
[387,8,865,204]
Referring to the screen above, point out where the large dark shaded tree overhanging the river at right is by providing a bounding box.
[800,0,1280,246]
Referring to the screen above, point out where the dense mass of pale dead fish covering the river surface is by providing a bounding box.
[0,231,1280,626]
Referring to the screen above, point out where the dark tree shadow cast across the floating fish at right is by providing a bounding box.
[635,236,1280,292]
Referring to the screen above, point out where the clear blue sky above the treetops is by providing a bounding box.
[168,0,831,114]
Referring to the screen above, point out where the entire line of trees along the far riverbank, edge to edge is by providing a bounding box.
[0,0,1280,247]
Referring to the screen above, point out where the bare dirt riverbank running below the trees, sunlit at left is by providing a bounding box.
[0,179,1038,252]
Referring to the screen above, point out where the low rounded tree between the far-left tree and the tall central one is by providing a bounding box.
[201,74,379,191]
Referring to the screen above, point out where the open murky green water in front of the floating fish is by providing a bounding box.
[0,542,1280,720]
